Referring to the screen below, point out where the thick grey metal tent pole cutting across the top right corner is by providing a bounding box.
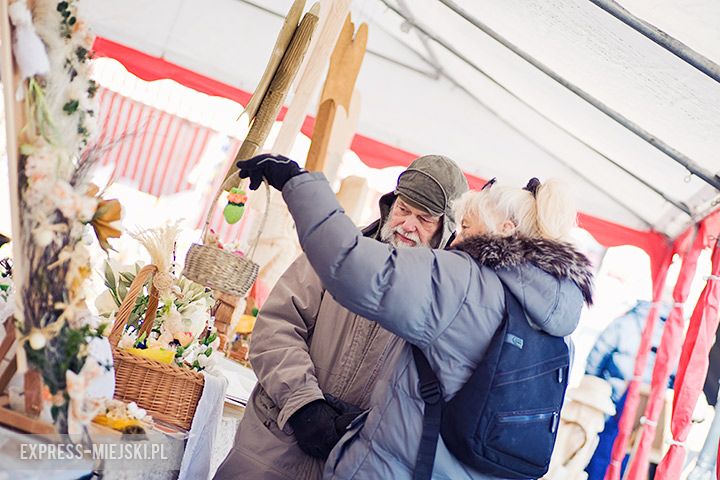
[590,0,720,82]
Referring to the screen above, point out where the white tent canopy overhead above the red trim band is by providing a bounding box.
[85,0,720,237]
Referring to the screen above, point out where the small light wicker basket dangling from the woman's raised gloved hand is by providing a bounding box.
[182,183,270,297]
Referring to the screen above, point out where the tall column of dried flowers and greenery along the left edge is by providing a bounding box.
[9,0,120,433]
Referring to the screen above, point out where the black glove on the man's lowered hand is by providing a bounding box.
[288,400,340,460]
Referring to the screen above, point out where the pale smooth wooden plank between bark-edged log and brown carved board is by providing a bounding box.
[272,0,350,155]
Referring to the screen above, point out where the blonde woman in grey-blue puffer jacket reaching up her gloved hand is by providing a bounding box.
[233,155,592,480]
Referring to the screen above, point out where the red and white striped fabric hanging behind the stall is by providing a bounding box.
[98,88,215,197]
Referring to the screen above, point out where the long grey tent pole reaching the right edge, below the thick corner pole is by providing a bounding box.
[440,0,720,194]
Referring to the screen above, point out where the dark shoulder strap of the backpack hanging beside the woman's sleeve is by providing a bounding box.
[412,345,443,480]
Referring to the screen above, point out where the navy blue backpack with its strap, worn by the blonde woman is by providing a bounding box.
[412,285,570,480]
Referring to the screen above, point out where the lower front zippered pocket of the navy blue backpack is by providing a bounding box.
[485,409,560,467]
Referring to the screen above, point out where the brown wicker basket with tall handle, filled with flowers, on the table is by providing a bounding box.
[110,265,205,430]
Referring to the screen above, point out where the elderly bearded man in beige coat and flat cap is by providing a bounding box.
[215,155,468,480]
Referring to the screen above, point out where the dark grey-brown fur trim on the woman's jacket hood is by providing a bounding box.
[454,235,593,305]
